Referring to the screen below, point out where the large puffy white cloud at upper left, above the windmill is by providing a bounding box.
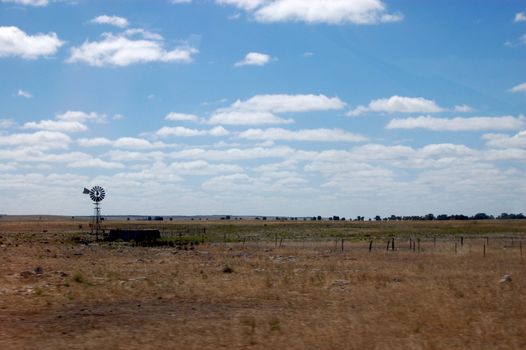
[67,33,198,67]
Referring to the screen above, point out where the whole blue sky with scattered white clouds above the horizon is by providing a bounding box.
[0,0,526,217]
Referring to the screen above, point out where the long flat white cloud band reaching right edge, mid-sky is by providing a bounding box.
[387,116,526,131]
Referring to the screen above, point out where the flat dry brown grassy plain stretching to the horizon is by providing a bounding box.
[0,218,526,349]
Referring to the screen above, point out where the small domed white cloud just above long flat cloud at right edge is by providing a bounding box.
[347,95,444,116]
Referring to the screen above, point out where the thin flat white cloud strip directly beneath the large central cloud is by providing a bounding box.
[239,128,367,142]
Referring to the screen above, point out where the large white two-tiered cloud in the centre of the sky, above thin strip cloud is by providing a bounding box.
[208,94,345,125]
